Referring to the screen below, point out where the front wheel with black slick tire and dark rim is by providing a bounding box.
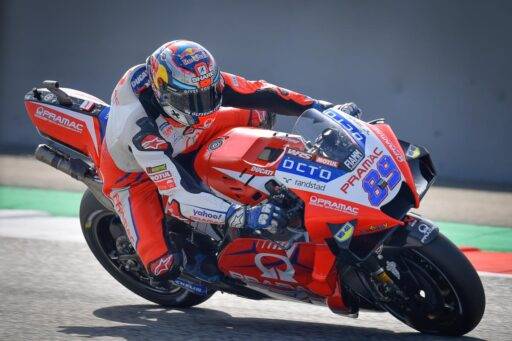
[378,234,485,336]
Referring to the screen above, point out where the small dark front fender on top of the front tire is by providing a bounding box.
[384,213,439,248]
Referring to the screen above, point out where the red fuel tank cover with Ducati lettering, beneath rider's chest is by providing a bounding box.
[194,127,304,205]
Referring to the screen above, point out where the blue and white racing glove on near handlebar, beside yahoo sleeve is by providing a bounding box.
[226,204,286,233]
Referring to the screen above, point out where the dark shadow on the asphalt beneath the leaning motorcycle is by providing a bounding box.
[59,305,480,341]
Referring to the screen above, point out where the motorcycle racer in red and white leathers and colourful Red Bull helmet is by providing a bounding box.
[99,40,360,280]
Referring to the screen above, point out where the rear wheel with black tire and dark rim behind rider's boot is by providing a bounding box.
[80,190,214,308]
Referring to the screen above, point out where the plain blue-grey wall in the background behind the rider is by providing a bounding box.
[0,0,512,185]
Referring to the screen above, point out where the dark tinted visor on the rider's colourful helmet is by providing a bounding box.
[161,82,223,116]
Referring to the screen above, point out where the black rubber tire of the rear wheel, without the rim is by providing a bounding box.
[80,190,214,308]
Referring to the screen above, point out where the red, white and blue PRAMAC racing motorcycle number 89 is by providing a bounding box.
[25,81,485,335]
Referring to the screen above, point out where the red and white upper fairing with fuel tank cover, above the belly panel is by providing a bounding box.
[195,112,419,239]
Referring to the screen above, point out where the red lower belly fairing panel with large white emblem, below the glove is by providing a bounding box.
[219,238,343,309]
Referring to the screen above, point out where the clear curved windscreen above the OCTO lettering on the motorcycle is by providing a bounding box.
[292,109,364,170]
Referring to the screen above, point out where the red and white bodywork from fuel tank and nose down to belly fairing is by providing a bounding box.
[194,112,419,311]
